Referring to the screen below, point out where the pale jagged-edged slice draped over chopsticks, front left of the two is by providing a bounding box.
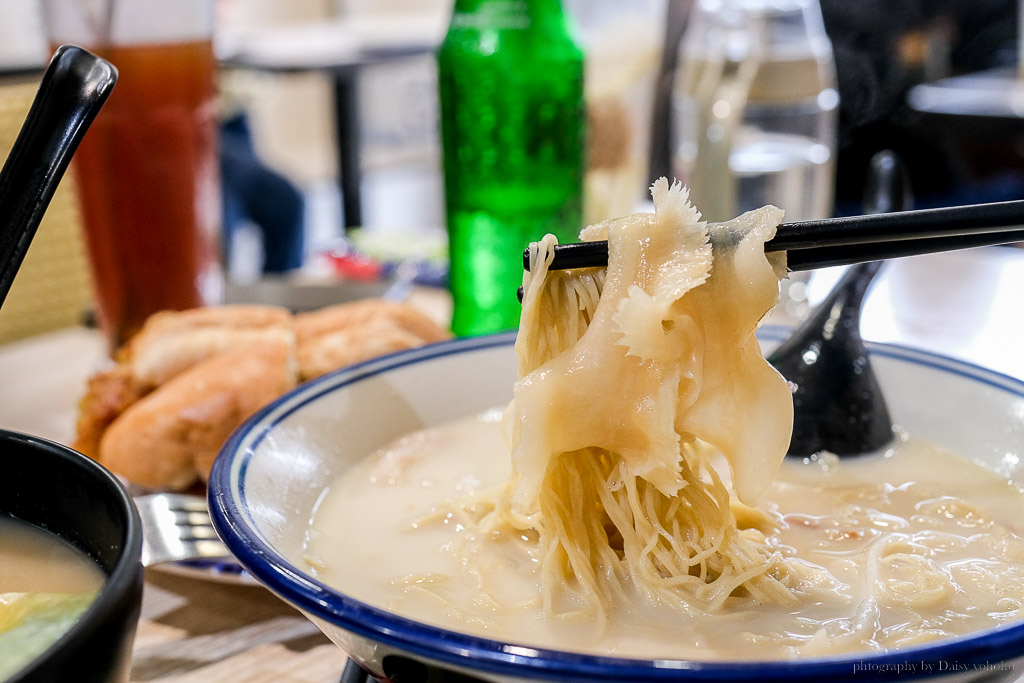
[513,179,712,514]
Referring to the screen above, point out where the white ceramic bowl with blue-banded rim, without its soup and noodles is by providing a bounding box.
[210,329,1024,683]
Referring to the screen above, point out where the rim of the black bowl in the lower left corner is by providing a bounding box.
[0,429,142,682]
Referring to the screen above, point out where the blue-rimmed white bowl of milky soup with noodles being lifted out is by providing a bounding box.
[210,182,1024,682]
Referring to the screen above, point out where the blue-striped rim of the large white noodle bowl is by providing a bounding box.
[209,326,1024,683]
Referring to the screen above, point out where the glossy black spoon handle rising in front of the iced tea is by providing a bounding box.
[0,45,118,304]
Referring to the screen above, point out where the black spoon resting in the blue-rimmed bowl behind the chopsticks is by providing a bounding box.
[768,152,909,457]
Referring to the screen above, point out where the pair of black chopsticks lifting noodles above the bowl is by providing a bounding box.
[523,200,1024,270]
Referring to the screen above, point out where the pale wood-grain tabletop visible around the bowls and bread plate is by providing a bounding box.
[0,248,1024,683]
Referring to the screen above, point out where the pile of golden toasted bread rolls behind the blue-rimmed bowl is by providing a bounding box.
[73,300,451,489]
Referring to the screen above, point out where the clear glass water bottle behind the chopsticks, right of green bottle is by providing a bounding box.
[671,0,839,322]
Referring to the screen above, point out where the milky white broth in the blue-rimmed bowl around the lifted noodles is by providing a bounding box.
[306,411,1024,659]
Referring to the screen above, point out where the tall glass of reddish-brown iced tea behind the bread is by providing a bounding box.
[43,0,222,350]
